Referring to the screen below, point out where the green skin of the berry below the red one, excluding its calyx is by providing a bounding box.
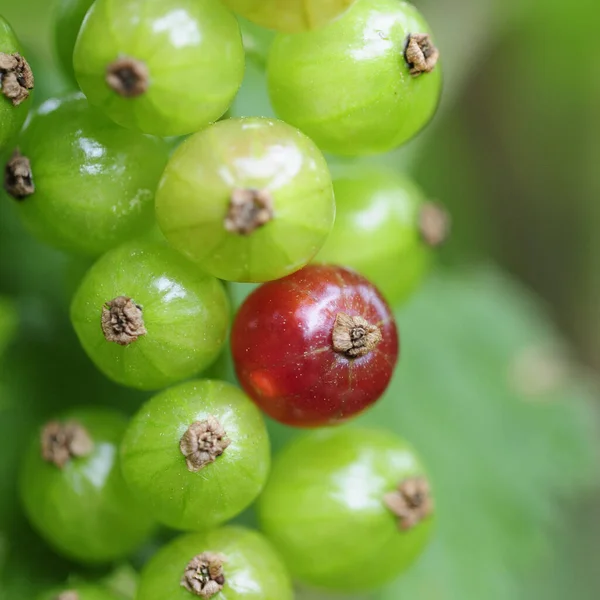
[258,427,434,593]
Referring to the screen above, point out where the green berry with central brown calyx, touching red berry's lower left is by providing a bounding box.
[121,380,270,531]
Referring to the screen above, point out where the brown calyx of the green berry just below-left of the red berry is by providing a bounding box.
[179,416,231,473]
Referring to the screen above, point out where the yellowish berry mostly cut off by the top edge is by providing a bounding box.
[224,0,355,33]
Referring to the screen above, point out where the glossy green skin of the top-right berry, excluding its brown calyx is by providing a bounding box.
[268,0,441,156]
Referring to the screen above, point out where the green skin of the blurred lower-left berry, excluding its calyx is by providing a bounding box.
[20,407,154,563]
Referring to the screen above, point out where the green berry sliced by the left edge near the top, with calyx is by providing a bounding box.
[0,15,34,151]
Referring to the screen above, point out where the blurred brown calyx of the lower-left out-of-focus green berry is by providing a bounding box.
[40,421,94,468]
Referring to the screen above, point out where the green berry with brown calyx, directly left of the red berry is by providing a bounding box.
[71,242,229,390]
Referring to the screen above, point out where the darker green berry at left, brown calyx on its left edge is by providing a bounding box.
[5,95,168,256]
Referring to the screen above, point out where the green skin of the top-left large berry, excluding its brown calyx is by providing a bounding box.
[73,0,245,136]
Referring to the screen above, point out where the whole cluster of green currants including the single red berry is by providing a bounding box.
[0,0,447,600]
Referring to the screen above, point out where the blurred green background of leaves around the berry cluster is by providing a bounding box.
[0,0,600,600]
